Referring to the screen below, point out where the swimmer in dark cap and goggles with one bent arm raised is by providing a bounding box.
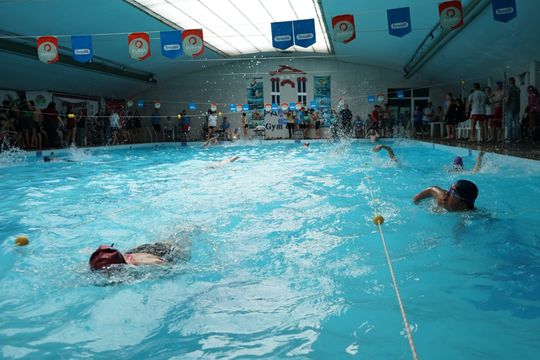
[413,180,478,211]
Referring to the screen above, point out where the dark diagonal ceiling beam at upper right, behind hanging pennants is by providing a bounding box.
[403,0,491,79]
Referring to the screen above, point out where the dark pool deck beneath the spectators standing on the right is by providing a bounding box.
[422,139,540,160]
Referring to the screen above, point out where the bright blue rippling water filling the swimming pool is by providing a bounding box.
[0,141,540,359]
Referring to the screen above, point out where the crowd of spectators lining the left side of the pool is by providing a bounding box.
[0,99,191,150]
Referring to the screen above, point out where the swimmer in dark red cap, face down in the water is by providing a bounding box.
[88,241,187,271]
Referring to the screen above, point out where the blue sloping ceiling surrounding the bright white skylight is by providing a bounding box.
[0,0,540,97]
